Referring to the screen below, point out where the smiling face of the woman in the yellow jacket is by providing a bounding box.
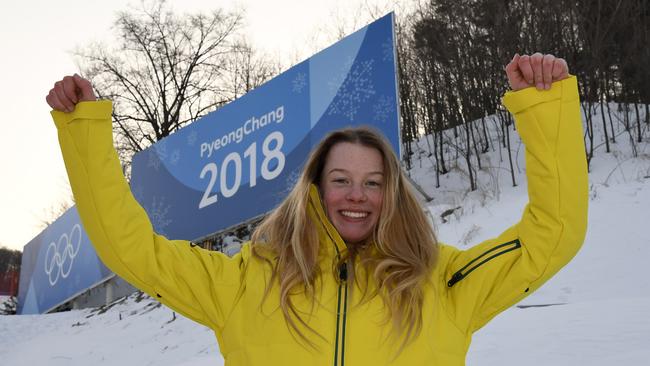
[321,142,384,243]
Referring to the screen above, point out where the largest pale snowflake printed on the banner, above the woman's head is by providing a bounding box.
[328,60,375,121]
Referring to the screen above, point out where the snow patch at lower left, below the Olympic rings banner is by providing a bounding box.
[0,295,223,366]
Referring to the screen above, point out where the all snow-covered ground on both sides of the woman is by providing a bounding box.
[0,104,650,366]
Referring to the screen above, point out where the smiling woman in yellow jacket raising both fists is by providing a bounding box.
[47,54,587,365]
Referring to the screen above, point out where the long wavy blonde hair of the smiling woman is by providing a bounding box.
[252,127,438,349]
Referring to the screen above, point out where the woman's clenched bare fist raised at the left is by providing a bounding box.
[45,74,97,113]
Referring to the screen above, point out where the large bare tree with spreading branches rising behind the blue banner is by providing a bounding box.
[76,0,274,163]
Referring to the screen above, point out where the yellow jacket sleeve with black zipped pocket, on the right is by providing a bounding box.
[442,77,588,332]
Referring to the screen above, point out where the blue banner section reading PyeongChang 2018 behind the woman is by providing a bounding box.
[131,13,400,240]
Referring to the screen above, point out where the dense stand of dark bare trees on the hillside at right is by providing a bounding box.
[388,0,650,194]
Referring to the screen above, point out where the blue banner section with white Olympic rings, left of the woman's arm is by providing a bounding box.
[17,206,113,314]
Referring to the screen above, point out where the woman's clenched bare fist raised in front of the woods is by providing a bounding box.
[506,52,569,91]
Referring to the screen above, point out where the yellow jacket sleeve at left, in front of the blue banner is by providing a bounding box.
[52,101,243,329]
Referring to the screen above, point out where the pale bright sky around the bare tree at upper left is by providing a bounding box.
[0,0,395,250]
